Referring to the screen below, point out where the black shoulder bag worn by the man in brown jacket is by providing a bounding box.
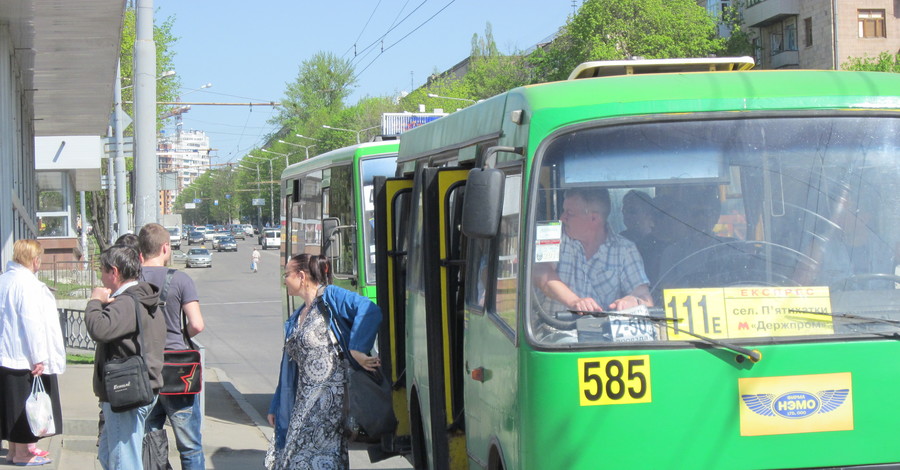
[103,295,155,413]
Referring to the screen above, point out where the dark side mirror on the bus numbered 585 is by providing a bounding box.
[462,168,506,238]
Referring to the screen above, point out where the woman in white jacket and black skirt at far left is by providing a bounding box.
[0,240,66,466]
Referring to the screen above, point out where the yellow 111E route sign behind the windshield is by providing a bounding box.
[663,286,834,341]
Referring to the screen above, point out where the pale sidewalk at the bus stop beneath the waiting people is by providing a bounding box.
[17,364,411,470]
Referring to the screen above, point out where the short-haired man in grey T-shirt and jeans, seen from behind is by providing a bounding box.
[138,223,206,470]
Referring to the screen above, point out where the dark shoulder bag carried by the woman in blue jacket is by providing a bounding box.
[319,296,397,439]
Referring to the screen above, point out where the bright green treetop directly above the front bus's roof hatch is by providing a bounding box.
[530,0,724,81]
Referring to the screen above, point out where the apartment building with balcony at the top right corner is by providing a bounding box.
[743,0,900,70]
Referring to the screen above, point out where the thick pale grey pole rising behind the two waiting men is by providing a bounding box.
[134,0,159,227]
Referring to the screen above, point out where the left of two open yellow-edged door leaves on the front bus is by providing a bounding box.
[374,176,412,444]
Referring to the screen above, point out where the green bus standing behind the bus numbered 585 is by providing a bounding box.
[281,140,399,306]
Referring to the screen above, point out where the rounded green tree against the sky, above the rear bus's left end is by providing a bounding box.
[271,52,356,129]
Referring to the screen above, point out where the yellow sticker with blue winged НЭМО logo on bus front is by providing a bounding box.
[738,372,853,436]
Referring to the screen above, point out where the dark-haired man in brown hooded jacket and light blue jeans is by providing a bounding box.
[84,245,166,470]
